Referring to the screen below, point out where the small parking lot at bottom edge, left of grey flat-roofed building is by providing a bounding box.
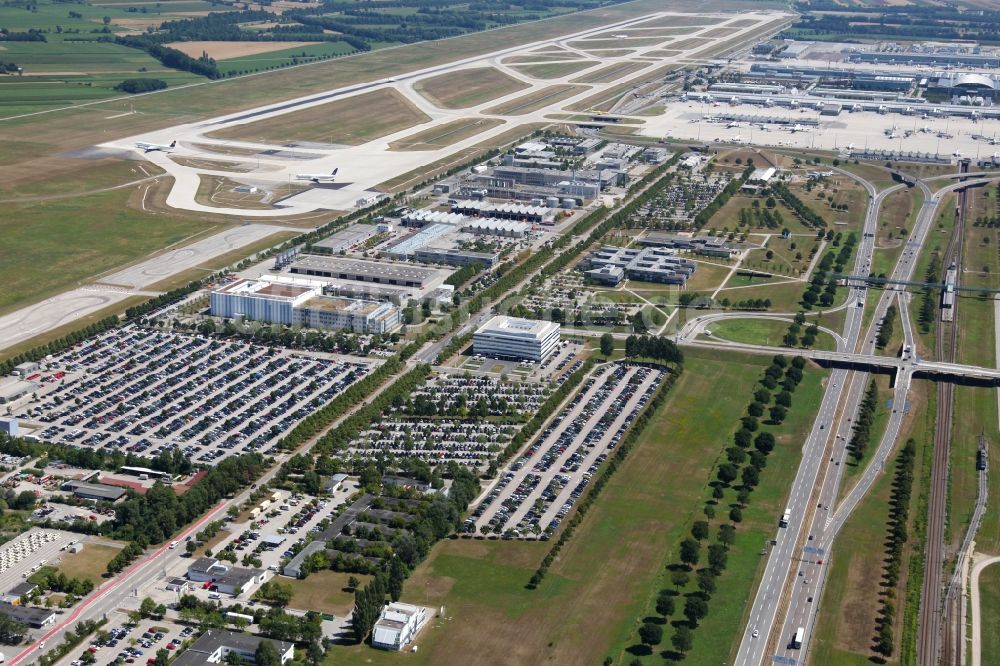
[56,613,194,666]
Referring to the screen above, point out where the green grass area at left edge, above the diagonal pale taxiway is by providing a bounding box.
[0,184,221,312]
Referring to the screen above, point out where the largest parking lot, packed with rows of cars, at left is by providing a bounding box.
[16,326,372,463]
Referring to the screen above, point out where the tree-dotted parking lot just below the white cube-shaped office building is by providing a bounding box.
[346,373,548,469]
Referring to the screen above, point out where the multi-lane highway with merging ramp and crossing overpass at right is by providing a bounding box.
[736,165,988,666]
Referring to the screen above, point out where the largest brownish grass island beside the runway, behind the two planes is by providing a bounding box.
[207,89,430,146]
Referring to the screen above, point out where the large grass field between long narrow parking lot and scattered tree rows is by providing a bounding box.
[328,354,818,664]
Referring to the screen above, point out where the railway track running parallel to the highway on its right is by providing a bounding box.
[917,165,967,666]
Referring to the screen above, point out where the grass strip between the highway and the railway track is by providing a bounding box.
[811,381,937,666]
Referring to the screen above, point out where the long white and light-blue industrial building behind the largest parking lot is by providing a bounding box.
[209,276,402,333]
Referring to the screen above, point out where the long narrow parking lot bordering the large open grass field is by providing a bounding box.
[465,364,663,539]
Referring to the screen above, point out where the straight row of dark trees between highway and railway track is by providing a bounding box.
[875,439,919,659]
